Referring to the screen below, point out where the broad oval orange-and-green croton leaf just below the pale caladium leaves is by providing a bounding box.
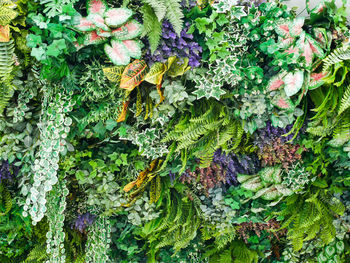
[120,59,147,91]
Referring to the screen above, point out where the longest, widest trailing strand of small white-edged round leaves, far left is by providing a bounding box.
[22,93,74,224]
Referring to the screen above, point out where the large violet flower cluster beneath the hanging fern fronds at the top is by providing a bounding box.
[146,20,202,67]
